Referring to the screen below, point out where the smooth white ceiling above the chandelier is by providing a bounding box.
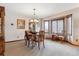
[2,3,79,18]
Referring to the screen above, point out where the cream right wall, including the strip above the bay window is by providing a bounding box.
[43,8,79,45]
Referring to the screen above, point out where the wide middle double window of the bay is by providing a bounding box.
[52,19,64,34]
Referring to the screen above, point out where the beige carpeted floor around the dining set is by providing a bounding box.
[5,40,79,56]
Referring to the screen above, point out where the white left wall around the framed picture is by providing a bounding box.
[5,7,28,41]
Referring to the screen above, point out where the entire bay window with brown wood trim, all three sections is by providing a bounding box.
[44,15,72,36]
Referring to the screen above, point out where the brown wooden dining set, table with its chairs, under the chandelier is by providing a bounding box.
[25,31,45,49]
